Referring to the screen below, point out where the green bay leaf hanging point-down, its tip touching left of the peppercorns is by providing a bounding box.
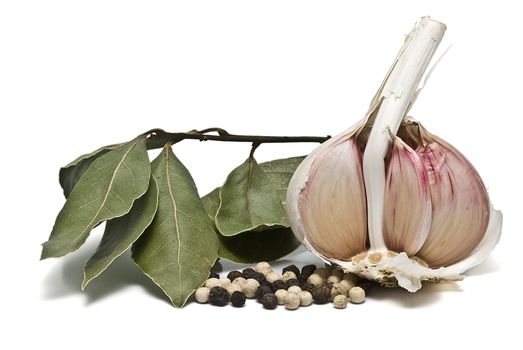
[132,146,218,307]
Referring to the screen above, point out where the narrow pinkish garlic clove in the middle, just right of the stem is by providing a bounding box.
[383,135,432,256]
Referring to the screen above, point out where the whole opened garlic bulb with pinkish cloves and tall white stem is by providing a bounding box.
[286,17,502,292]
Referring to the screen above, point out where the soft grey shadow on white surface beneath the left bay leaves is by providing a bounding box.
[43,244,170,305]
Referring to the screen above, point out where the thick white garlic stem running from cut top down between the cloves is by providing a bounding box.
[363,17,446,251]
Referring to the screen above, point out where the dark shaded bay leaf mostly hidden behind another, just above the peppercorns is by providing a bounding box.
[202,189,301,264]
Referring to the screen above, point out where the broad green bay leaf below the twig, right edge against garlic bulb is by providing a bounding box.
[215,156,299,236]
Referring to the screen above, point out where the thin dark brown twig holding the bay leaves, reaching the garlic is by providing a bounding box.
[144,128,330,149]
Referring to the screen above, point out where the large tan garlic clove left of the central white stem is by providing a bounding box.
[299,137,367,259]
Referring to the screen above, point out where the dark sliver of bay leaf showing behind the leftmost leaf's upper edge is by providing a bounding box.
[58,144,121,198]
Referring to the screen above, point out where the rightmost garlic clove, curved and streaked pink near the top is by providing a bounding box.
[416,125,490,268]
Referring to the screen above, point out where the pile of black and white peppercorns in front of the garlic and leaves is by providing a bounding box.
[195,262,371,310]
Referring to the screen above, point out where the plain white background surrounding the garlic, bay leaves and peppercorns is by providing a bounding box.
[0,0,523,349]
